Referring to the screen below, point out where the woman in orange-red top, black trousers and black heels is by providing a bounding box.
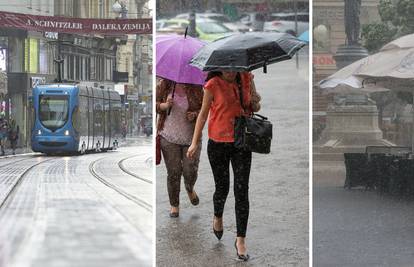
[187,71,260,261]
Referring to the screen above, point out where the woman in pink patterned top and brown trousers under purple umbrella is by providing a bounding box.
[156,78,203,217]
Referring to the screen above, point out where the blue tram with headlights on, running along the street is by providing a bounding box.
[31,84,122,154]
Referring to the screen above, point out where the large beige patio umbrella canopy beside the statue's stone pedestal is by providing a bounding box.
[319,34,414,152]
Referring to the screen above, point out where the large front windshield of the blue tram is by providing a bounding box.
[39,95,69,131]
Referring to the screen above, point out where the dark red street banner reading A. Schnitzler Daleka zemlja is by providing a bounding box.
[0,11,152,35]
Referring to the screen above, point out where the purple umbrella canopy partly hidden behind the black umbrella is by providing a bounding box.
[156,34,206,85]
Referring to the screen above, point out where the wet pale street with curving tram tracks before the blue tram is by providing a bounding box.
[0,138,153,267]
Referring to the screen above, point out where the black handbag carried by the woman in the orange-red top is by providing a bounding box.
[234,80,273,154]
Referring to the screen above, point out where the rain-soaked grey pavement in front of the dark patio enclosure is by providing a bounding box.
[313,161,414,267]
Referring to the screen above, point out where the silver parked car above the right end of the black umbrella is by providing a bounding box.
[263,12,309,36]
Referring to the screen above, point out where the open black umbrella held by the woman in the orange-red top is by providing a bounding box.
[190,32,306,72]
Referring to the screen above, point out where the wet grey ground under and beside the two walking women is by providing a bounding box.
[156,51,309,266]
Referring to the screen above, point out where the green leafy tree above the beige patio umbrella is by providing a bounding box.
[361,0,414,52]
